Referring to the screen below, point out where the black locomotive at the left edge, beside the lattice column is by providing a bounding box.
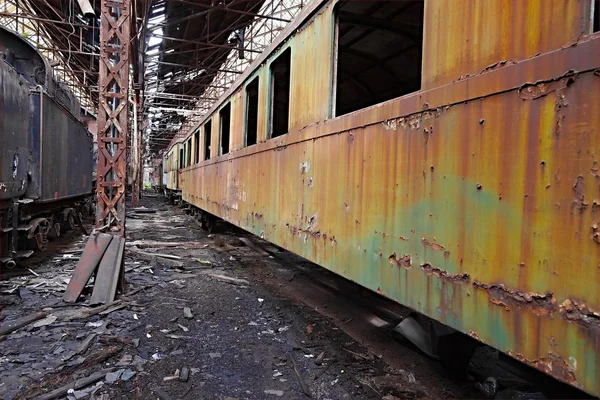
[0,27,95,267]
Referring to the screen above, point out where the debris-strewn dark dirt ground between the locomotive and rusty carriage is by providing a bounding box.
[0,195,580,400]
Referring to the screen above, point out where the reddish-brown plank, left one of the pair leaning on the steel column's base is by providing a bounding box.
[63,233,112,303]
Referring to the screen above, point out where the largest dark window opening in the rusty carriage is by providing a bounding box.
[333,1,424,116]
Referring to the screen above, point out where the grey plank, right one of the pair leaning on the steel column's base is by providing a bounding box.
[90,237,125,304]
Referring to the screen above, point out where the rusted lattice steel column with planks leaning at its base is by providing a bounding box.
[96,0,131,236]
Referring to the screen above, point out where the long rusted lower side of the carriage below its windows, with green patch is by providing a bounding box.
[182,26,600,395]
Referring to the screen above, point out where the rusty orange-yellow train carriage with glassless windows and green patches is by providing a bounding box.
[165,0,600,395]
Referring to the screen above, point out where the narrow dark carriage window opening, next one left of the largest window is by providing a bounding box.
[271,48,292,137]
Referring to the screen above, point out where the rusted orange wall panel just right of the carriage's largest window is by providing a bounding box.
[423,0,592,89]
